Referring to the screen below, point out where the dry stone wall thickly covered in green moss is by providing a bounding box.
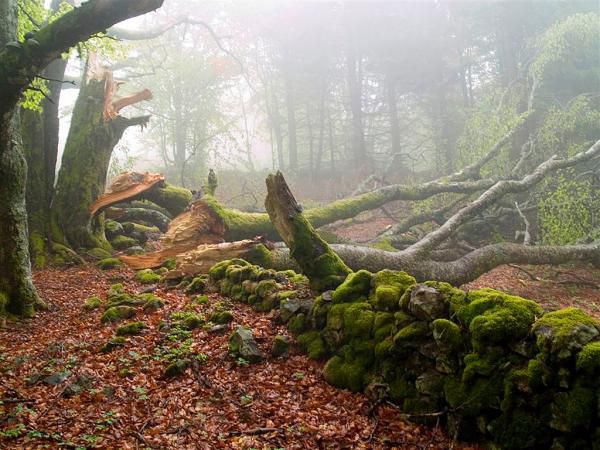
[204,260,600,450]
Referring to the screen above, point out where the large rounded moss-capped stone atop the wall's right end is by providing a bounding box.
[533,308,600,359]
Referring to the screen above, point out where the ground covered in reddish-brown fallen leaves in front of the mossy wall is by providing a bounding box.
[0,265,476,449]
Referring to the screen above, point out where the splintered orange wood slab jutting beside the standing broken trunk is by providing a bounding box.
[90,172,165,217]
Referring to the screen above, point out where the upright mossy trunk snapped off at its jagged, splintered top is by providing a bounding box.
[52,76,148,249]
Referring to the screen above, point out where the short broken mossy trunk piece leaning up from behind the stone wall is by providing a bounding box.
[265,172,351,290]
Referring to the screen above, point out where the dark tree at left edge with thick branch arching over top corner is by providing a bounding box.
[0,0,162,316]
